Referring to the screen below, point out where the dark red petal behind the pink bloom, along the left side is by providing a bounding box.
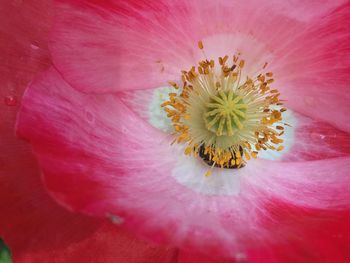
[0,0,176,263]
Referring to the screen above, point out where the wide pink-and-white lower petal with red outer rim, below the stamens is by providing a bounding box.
[18,69,350,257]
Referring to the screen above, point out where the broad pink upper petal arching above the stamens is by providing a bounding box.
[50,0,350,131]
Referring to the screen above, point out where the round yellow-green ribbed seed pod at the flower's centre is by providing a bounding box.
[203,90,247,136]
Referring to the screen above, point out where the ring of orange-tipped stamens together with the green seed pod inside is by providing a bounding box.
[161,41,288,173]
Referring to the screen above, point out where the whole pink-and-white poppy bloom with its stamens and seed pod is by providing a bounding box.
[2,1,350,262]
